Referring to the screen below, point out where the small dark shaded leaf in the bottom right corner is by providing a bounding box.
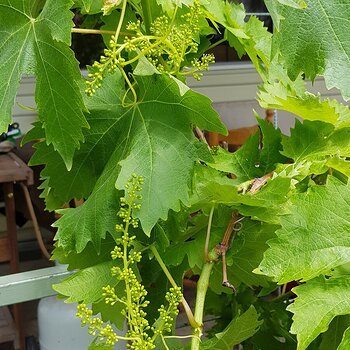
[319,315,350,350]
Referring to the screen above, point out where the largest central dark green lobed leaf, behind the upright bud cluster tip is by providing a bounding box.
[31,72,226,252]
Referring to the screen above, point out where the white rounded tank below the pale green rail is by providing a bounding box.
[38,296,126,350]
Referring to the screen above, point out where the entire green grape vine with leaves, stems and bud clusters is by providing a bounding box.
[0,0,350,350]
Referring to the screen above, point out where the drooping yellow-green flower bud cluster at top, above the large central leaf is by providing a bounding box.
[85,1,215,97]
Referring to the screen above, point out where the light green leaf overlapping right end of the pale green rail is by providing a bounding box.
[52,261,118,304]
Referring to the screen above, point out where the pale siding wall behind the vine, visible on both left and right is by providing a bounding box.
[13,62,342,133]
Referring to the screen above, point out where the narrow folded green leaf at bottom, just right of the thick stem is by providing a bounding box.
[200,306,262,350]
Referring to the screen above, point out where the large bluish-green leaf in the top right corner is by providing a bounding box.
[274,0,350,100]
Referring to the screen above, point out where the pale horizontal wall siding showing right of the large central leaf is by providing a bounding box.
[188,63,344,134]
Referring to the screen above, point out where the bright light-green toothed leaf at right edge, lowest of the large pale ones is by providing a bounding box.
[287,276,350,350]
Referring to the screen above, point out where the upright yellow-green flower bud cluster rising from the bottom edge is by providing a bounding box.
[76,174,182,350]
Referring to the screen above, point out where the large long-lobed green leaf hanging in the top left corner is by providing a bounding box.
[0,0,88,169]
